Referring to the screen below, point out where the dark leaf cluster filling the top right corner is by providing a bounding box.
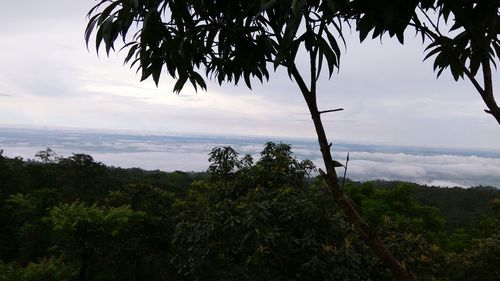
[423,0,500,80]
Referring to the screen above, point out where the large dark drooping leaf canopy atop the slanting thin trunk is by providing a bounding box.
[85,0,346,92]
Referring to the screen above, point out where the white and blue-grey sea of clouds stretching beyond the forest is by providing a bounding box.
[0,128,500,187]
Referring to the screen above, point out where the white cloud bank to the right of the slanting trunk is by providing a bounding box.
[332,152,500,187]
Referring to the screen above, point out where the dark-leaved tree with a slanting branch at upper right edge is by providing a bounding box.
[350,0,500,124]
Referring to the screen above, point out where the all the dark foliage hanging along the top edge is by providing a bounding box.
[85,0,500,95]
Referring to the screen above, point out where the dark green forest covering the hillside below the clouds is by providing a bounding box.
[0,142,500,281]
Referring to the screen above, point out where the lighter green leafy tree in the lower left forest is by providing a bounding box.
[43,201,145,281]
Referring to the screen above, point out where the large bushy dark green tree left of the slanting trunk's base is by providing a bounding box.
[176,142,378,280]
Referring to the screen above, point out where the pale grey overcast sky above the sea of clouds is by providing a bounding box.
[0,0,500,150]
